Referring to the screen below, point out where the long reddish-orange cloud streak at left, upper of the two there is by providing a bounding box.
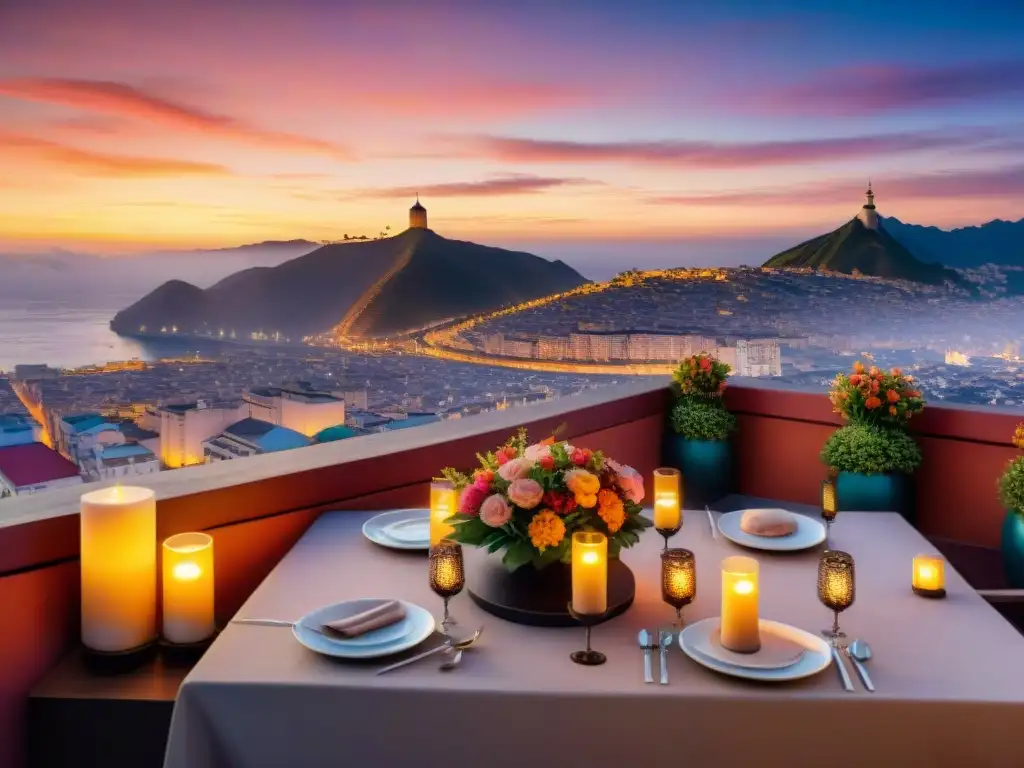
[0,78,351,160]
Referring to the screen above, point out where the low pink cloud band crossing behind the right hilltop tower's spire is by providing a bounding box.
[647,165,1024,207]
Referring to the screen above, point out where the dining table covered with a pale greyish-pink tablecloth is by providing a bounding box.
[165,496,1024,768]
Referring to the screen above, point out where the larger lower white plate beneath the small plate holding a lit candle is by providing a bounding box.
[679,616,831,683]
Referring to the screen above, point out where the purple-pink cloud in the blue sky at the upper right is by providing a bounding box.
[757,60,1024,116]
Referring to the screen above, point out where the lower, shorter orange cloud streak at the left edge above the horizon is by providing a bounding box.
[0,133,230,177]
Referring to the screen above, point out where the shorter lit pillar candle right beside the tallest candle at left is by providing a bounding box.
[163,534,216,643]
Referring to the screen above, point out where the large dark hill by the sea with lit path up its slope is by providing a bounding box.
[111,229,587,338]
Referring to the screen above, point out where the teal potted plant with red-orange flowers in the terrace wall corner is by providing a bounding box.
[663,352,736,506]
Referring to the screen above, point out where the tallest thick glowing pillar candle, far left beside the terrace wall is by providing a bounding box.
[80,486,157,653]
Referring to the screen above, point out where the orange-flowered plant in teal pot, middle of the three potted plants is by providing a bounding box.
[821,360,925,518]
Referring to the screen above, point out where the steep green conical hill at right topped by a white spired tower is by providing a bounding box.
[764,186,959,285]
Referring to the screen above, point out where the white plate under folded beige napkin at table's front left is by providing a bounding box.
[292,598,434,658]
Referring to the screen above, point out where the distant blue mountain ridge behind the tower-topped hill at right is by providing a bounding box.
[882,217,1024,267]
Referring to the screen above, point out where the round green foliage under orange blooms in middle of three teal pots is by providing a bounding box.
[821,424,921,475]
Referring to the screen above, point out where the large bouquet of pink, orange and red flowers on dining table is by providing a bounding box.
[443,429,652,570]
